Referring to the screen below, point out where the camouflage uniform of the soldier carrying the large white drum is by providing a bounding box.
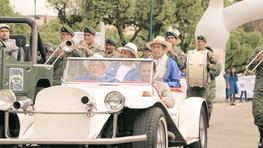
[187,50,221,115]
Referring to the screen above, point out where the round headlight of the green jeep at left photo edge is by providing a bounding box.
[0,89,16,111]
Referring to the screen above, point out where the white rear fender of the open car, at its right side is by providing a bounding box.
[178,97,205,138]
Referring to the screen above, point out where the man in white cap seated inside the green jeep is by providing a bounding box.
[0,24,25,60]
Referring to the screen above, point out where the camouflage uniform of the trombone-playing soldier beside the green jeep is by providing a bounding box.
[51,49,85,85]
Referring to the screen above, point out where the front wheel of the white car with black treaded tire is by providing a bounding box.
[133,107,168,148]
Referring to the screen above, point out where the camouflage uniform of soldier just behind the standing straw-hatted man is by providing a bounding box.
[167,47,187,70]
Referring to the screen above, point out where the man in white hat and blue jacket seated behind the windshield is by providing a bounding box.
[102,42,140,82]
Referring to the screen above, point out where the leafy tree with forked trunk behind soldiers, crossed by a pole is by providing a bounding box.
[83,0,187,44]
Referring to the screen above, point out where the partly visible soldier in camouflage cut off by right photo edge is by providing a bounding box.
[249,48,263,148]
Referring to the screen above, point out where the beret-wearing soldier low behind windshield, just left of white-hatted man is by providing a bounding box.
[104,39,120,58]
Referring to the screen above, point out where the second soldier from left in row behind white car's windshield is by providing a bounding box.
[79,26,103,57]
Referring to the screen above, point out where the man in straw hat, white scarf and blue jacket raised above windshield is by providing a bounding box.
[146,36,180,108]
